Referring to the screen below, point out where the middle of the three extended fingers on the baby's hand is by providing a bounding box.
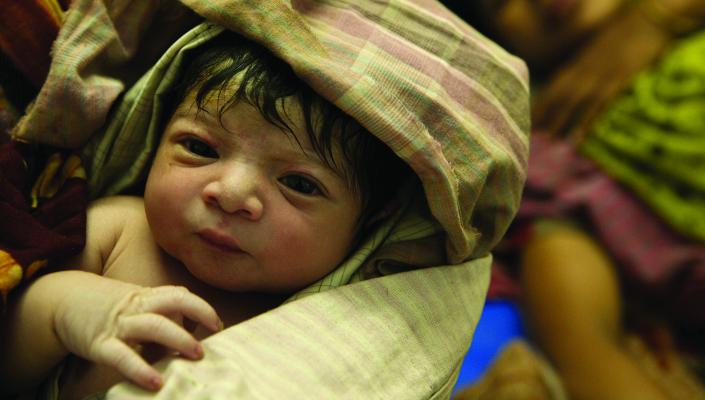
[120,314,203,360]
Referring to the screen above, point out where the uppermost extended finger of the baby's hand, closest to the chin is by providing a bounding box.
[143,286,223,331]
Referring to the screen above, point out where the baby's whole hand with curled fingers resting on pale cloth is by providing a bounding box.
[54,272,222,390]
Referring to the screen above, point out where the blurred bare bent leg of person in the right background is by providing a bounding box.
[520,224,705,400]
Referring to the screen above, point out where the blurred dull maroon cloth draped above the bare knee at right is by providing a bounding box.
[489,134,705,329]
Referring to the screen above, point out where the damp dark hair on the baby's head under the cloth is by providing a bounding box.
[165,32,411,231]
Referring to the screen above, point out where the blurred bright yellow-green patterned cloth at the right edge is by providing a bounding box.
[582,32,705,242]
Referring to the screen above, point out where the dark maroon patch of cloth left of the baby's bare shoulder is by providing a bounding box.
[0,142,87,306]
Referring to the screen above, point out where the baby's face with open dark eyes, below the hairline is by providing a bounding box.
[145,96,361,291]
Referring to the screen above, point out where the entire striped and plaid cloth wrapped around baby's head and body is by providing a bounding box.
[14,0,529,398]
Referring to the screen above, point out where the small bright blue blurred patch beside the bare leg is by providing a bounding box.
[453,300,526,394]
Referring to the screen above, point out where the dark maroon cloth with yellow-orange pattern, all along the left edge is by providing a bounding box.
[0,0,87,305]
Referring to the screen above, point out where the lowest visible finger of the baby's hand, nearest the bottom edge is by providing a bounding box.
[94,338,163,390]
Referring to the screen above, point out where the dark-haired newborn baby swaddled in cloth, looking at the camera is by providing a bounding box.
[0,29,409,398]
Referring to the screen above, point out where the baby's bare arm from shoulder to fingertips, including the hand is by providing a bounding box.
[0,198,220,392]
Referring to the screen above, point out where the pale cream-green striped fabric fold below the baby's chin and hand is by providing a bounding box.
[106,257,490,400]
